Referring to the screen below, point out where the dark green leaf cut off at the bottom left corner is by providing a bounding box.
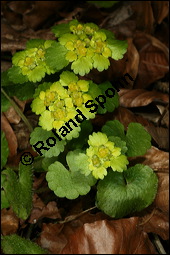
[2,234,48,254]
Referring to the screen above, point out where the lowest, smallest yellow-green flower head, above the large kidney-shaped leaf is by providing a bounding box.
[86,132,129,179]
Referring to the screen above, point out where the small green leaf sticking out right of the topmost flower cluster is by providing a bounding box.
[107,38,128,60]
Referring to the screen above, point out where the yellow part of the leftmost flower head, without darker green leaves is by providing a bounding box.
[12,40,54,82]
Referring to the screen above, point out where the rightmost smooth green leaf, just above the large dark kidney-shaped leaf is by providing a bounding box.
[126,123,151,157]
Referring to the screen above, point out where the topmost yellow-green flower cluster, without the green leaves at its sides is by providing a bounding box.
[59,21,112,75]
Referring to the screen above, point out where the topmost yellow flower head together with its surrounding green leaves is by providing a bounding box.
[46,20,127,76]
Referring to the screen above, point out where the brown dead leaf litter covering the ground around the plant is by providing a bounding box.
[1,1,169,254]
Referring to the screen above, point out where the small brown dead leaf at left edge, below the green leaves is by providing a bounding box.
[1,208,19,235]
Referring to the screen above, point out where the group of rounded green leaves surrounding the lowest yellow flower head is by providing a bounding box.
[31,120,158,218]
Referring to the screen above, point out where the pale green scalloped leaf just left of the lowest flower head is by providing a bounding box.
[46,161,94,199]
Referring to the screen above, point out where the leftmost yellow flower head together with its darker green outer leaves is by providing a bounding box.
[8,39,55,83]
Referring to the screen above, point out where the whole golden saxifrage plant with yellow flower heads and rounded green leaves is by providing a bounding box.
[1,20,158,218]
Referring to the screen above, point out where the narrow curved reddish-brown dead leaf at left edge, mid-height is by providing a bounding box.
[1,113,18,157]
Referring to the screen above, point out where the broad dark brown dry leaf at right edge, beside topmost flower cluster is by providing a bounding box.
[133,32,169,88]
